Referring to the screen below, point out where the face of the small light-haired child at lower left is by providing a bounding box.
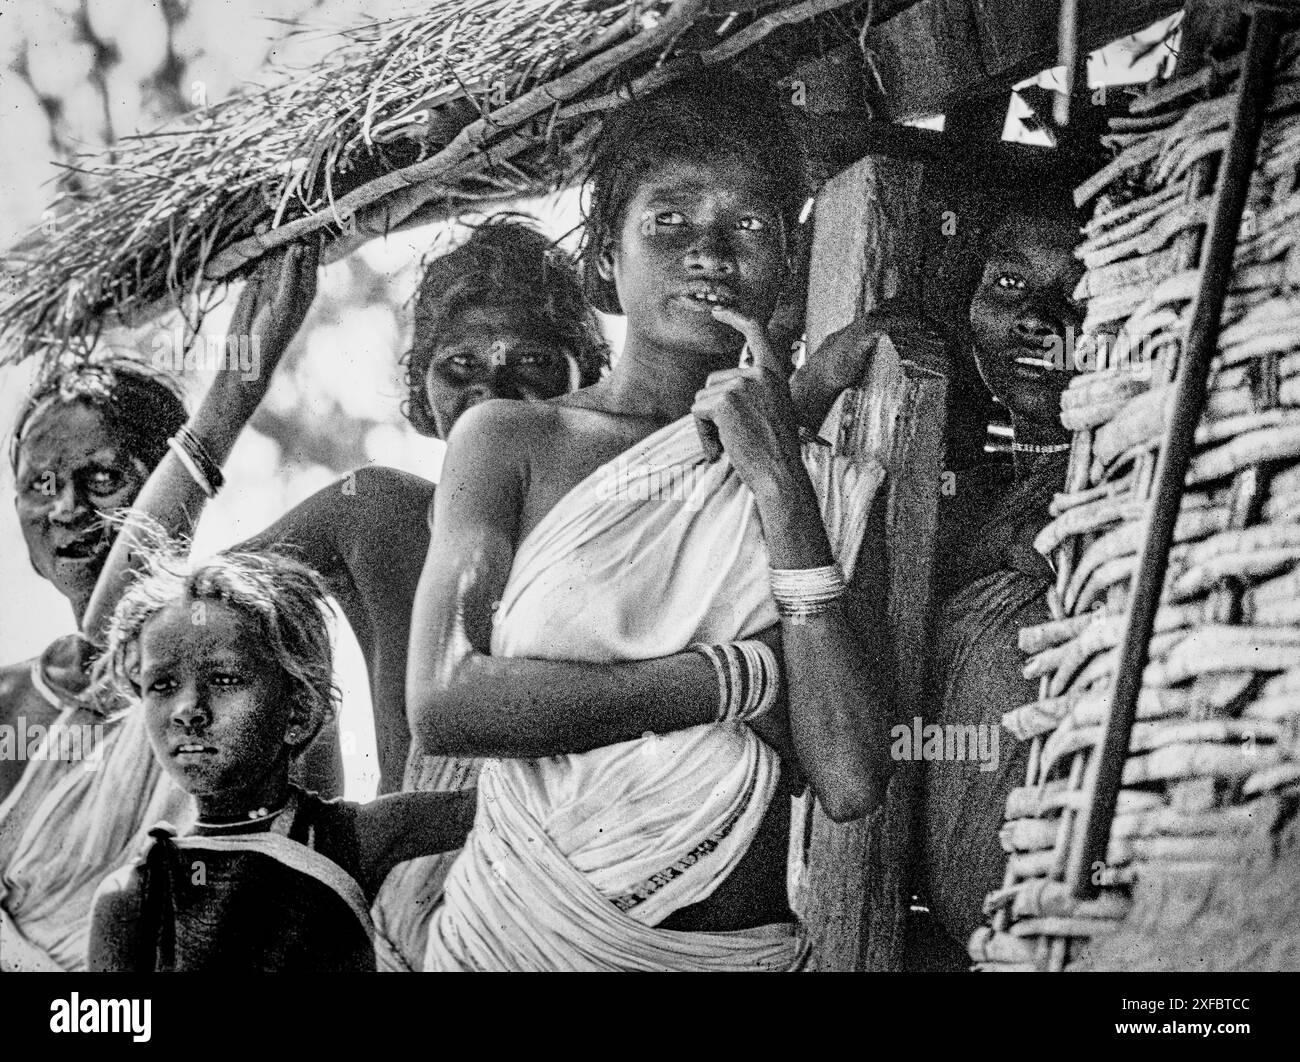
[139,601,300,814]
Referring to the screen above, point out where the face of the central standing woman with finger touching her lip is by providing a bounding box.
[601,159,787,360]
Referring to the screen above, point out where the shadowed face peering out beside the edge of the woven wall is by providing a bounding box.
[970,214,1083,432]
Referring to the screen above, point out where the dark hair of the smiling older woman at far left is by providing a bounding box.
[9,355,189,471]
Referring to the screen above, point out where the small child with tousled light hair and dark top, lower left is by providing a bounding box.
[90,552,475,972]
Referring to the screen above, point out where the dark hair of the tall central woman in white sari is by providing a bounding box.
[579,71,809,313]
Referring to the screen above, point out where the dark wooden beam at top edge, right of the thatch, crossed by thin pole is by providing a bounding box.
[863,0,1182,121]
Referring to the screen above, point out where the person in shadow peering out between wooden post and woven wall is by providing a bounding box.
[922,178,1083,946]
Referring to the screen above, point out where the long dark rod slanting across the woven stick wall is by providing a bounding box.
[1067,5,1282,900]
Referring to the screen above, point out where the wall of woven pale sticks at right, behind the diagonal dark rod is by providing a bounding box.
[970,26,1300,970]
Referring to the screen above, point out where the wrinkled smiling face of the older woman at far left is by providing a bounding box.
[14,400,148,615]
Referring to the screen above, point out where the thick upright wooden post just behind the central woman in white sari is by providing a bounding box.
[790,159,946,970]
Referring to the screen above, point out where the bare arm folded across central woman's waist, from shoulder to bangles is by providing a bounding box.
[407,402,718,758]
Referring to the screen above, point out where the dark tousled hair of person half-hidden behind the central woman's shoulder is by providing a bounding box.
[402,213,610,435]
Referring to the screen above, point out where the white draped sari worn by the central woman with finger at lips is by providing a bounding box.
[425,416,883,970]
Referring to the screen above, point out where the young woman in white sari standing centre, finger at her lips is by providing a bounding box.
[407,78,887,970]
